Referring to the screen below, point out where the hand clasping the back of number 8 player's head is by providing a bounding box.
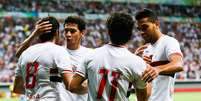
[32,20,52,36]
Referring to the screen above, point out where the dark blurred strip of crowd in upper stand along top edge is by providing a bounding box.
[0,0,201,17]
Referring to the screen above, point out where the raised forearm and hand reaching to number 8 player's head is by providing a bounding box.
[16,20,52,58]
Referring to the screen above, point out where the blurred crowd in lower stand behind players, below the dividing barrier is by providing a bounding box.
[0,18,201,82]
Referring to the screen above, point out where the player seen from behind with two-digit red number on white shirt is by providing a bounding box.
[69,13,149,101]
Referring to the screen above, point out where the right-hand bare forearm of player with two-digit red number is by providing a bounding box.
[135,83,151,101]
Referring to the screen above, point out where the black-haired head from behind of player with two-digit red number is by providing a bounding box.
[106,13,134,45]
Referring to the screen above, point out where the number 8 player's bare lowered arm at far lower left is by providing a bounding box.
[13,76,25,94]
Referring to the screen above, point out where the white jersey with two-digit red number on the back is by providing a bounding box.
[76,44,147,101]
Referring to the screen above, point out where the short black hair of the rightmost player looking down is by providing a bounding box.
[135,8,158,22]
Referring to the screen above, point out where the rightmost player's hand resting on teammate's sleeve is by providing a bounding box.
[141,65,159,82]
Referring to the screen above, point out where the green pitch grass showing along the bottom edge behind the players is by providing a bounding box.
[0,92,201,101]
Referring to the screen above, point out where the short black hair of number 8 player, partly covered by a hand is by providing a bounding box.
[39,16,59,42]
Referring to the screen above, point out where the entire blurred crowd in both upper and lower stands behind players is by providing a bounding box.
[0,0,201,82]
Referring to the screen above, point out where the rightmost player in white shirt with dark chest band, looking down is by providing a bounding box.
[135,9,183,101]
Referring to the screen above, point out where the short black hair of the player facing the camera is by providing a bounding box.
[64,16,86,31]
